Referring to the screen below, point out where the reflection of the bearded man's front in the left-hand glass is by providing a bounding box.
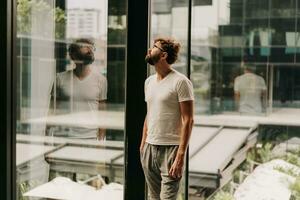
[56,39,107,139]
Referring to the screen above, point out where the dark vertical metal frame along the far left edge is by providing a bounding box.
[0,0,16,200]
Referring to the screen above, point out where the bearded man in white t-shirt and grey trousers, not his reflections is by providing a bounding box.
[140,38,194,200]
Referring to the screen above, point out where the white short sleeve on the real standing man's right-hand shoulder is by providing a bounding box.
[176,79,194,102]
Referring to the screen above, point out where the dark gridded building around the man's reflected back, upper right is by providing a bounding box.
[212,0,300,115]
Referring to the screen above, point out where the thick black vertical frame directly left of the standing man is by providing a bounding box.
[124,0,148,200]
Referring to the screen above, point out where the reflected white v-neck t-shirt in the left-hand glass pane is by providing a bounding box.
[56,68,107,138]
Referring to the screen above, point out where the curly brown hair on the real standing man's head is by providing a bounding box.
[154,38,180,65]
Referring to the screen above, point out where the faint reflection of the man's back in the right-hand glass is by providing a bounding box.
[234,64,267,114]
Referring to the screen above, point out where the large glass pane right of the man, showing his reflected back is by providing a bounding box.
[189,0,300,200]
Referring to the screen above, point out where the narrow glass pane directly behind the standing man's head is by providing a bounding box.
[149,0,189,199]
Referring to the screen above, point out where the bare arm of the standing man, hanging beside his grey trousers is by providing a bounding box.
[169,101,194,178]
